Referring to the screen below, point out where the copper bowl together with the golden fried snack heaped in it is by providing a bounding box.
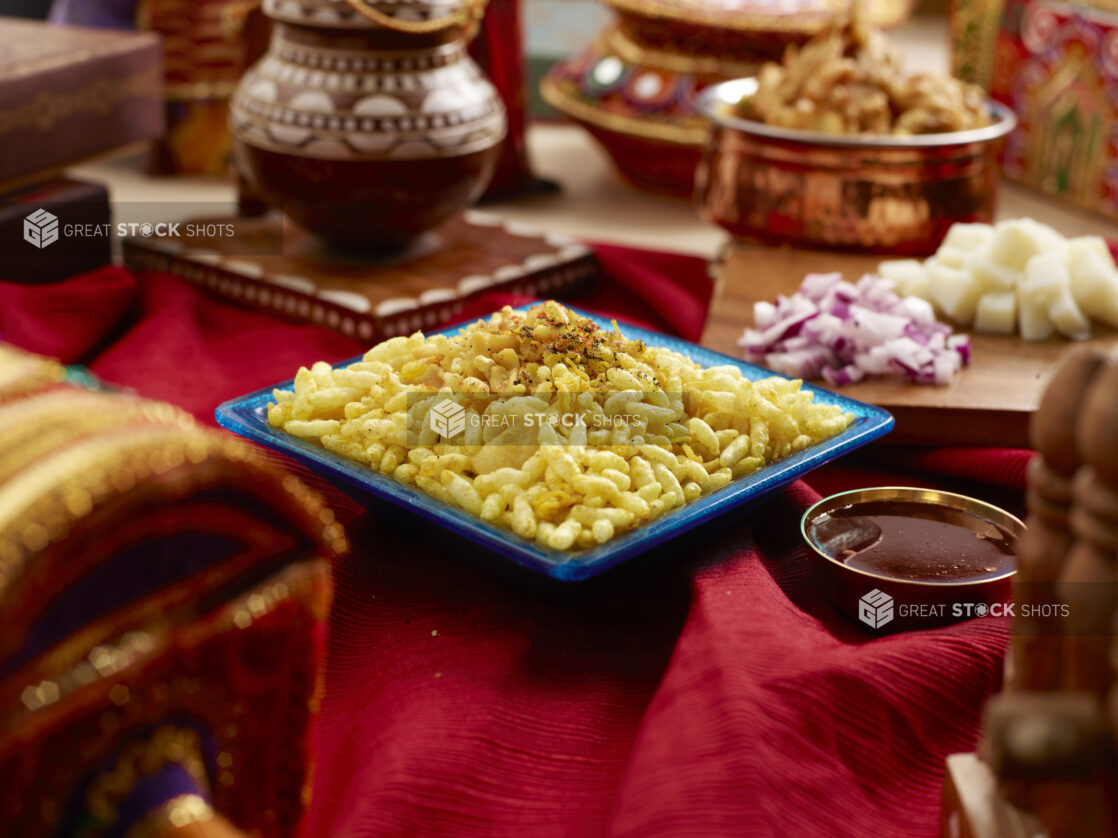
[695,6,1016,255]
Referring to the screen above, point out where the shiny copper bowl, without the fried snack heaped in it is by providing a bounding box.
[695,78,1017,256]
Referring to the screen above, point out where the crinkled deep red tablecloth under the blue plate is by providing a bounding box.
[0,248,1029,838]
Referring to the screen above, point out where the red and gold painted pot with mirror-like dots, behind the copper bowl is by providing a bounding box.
[540,0,912,197]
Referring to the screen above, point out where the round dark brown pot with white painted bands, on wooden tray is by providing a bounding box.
[230,0,505,250]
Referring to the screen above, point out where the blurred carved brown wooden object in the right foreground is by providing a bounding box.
[942,347,1118,838]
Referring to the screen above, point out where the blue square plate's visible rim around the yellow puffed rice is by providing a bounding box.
[216,305,893,582]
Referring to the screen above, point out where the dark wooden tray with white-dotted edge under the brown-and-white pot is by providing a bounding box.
[123,211,598,343]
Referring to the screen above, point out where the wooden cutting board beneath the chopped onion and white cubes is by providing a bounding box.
[702,245,1118,447]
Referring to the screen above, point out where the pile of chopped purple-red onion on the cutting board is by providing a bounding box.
[738,274,970,387]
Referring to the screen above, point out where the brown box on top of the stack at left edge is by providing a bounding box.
[0,18,163,191]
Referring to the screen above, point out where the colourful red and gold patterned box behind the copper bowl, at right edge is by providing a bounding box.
[951,0,1118,220]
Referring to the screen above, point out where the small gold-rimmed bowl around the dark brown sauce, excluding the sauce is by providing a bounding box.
[799,486,1025,632]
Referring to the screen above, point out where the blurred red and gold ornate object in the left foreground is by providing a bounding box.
[0,345,345,838]
